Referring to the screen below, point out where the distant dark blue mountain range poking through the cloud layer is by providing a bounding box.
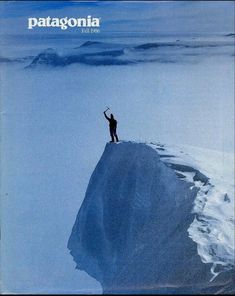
[0,36,234,68]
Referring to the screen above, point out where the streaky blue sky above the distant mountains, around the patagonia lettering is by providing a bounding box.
[0,1,234,34]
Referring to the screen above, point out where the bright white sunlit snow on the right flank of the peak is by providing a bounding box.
[150,144,235,280]
